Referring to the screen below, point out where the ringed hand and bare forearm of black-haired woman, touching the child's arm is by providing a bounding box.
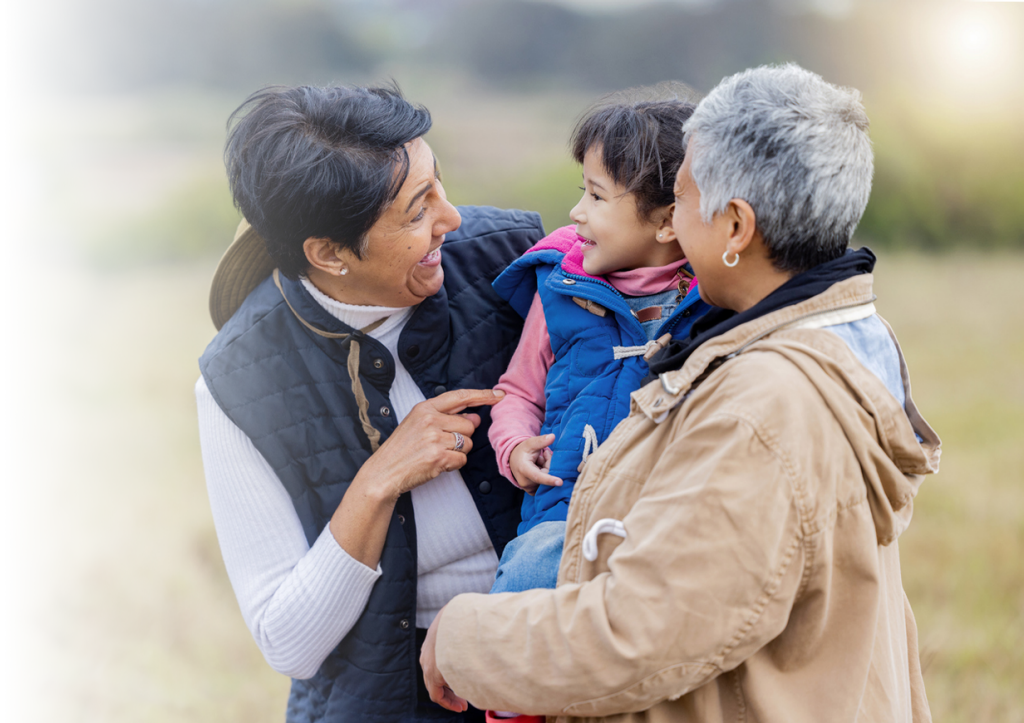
[331,389,505,567]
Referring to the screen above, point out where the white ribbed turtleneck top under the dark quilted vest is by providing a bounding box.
[196,280,498,678]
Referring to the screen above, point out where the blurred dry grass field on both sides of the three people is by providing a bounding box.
[4,246,1024,723]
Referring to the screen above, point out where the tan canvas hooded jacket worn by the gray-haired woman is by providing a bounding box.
[437,274,940,723]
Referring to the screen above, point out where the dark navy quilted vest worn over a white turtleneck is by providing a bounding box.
[200,207,544,723]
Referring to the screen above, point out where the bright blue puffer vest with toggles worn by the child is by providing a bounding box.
[495,239,711,535]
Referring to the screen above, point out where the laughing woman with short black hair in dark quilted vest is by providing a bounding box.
[196,87,544,722]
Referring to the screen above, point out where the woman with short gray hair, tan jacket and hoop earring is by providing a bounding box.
[423,66,939,723]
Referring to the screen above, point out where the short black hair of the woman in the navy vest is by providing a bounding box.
[224,86,431,279]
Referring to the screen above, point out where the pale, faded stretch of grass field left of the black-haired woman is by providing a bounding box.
[5,262,288,722]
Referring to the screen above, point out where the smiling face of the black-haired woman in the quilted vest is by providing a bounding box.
[321,138,462,307]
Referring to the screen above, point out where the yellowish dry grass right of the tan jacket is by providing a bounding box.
[877,250,1024,723]
